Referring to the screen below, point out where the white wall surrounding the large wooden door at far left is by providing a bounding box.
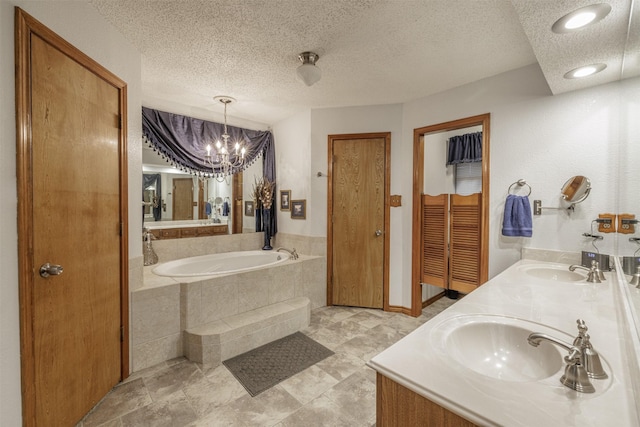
[0,0,142,426]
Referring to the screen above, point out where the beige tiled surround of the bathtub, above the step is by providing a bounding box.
[131,254,326,372]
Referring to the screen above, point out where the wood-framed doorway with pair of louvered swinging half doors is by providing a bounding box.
[411,114,490,316]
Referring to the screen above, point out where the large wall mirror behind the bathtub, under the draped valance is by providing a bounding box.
[142,147,262,233]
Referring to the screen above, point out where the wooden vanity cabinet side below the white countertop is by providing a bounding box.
[376,373,478,427]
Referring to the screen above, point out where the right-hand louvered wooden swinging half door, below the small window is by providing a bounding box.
[449,193,482,294]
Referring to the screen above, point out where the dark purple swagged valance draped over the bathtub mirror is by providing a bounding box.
[142,107,278,235]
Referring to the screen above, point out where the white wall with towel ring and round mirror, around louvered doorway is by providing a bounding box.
[403,65,640,304]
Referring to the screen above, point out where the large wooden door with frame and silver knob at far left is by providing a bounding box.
[16,9,129,426]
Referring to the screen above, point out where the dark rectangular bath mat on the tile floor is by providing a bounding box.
[222,332,333,396]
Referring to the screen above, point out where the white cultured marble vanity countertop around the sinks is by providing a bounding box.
[369,260,640,427]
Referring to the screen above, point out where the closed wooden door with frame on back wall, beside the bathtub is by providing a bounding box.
[327,133,390,308]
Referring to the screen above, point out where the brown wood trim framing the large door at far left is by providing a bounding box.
[14,7,129,426]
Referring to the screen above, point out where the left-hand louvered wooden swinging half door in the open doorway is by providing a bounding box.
[420,194,449,289]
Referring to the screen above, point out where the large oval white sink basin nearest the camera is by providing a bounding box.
[439,315,571,382]
